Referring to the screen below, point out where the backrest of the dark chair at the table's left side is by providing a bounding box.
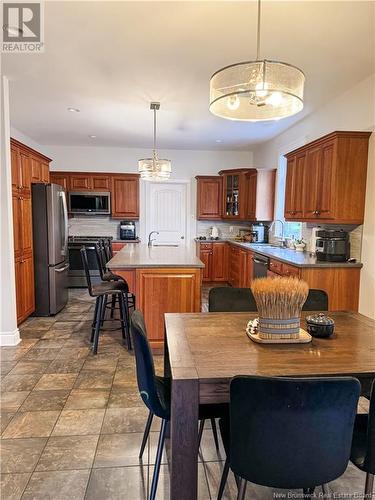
[130,311,169,418]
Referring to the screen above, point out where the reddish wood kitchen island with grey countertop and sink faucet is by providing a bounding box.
[108,244,204,348]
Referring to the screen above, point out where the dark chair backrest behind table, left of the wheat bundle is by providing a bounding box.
[208,286,257,312]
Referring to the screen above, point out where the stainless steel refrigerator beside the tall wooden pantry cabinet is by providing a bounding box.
[32,184,69,316]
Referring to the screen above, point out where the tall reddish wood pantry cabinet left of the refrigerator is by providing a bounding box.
[10,139,51,324]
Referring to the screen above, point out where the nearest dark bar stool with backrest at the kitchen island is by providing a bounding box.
[80,246,132,354]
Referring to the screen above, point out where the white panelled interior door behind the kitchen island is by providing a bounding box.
[145,181,188,246]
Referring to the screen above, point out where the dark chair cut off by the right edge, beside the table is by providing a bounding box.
[350,382,375,498]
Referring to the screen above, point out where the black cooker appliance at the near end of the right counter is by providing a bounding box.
[315,229,350,262]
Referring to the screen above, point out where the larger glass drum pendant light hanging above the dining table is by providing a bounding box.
[210,0,305,121]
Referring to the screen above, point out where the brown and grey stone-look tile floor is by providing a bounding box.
[0,290,366,500]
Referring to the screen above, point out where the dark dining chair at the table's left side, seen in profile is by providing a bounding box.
[130,311,228,500]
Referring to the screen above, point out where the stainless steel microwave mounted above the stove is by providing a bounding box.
[69,191,111,215]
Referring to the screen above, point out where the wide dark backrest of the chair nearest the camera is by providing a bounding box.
[230,376,360,489]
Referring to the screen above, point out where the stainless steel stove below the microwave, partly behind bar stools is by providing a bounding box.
[68,236,113,288]
